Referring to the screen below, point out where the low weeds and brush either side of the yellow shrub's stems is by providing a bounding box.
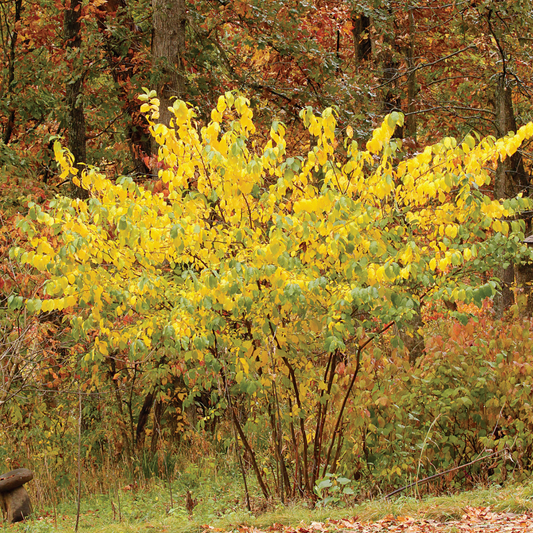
[5,310,533,514]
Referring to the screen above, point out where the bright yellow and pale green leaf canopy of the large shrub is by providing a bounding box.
[14,93,533,416]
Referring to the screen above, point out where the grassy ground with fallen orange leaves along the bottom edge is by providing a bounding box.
[14,480,533,533]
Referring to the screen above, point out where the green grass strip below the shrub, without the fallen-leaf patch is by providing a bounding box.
[10,467,533,533]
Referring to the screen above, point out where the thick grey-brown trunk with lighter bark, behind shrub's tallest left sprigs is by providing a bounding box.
[152,0,186,126]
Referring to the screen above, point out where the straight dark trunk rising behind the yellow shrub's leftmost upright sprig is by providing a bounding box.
[63,0,89,199]
